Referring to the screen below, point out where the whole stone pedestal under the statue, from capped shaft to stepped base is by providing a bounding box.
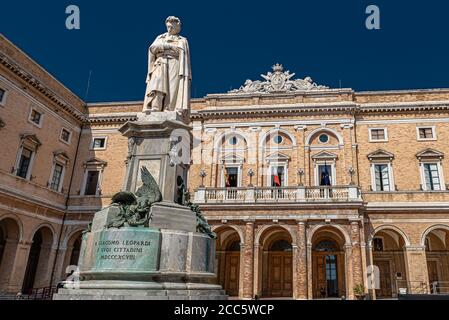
[54,113,227,300]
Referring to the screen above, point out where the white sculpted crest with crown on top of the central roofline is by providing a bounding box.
[229,63,329,94]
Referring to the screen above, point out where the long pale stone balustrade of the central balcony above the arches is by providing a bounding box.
[195,186,362,203]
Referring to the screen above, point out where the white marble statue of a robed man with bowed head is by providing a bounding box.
[143,16,192,113]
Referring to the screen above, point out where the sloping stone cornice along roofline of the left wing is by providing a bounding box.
[0,52,87,122]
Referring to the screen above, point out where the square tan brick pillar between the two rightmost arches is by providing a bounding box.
[404,245,430,294]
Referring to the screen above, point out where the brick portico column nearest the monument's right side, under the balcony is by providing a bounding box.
[241,221,254,299]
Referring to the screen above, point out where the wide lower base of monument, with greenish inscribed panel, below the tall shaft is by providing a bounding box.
[54,206,227,300]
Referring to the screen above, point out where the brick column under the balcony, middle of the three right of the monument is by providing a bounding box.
[293,221,312,300]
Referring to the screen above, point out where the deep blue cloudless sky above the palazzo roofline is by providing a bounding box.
[0,0,449,102]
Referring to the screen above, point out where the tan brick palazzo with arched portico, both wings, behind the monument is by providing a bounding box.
[0,37,449,299]
